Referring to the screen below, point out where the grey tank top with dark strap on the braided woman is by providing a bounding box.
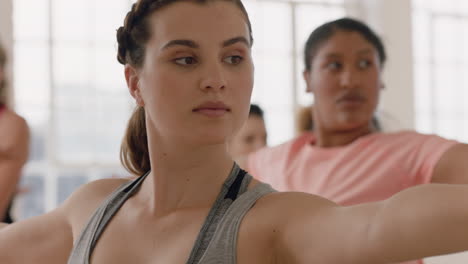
[68,164,275,264]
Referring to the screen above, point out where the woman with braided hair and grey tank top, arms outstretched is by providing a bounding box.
[0,0,468,264]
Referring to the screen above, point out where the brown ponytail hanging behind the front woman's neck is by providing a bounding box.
[120,106,151,175]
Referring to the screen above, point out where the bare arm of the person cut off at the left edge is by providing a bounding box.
[0,112,29,219]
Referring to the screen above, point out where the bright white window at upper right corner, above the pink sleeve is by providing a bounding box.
[413,0,468,142]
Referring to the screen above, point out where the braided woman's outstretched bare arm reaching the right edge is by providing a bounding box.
[270,184,468,263]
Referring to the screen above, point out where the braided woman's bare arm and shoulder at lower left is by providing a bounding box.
[0,179,128,264]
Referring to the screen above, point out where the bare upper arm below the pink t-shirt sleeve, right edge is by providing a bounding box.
[431,143,468,184]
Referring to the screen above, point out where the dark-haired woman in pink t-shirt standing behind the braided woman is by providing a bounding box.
[249,18,468,262]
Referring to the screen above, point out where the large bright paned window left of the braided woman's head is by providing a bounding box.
[13,0,132,218]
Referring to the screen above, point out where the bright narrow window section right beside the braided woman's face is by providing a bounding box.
[246,2,294,145]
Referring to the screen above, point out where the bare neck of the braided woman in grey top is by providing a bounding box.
[142,136,233,215]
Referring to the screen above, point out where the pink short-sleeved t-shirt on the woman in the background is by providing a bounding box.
[247,131,457,263]
